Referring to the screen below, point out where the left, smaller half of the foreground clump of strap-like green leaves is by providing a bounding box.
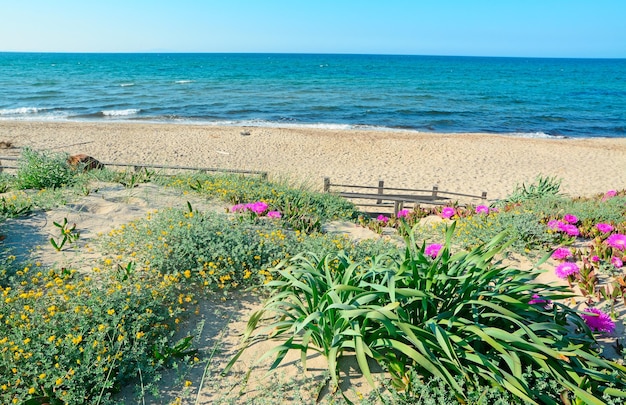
[225,254,385,387]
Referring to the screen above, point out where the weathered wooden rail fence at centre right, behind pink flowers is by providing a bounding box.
[324,177,487,215]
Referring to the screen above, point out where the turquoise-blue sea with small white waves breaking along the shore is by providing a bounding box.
[0,53,626,138]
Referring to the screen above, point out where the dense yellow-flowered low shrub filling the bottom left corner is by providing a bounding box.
[0,267,192,404]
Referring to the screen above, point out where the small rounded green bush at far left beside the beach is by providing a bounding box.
[16,147,74,189]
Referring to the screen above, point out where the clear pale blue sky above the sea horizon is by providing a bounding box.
[0,0,626,58]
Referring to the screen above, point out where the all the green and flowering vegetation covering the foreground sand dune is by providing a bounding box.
[0,150,626,404]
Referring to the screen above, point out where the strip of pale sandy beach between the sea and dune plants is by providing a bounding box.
[0,121,626,200]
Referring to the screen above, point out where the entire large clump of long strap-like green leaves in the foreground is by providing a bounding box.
[231,225,626,404]
